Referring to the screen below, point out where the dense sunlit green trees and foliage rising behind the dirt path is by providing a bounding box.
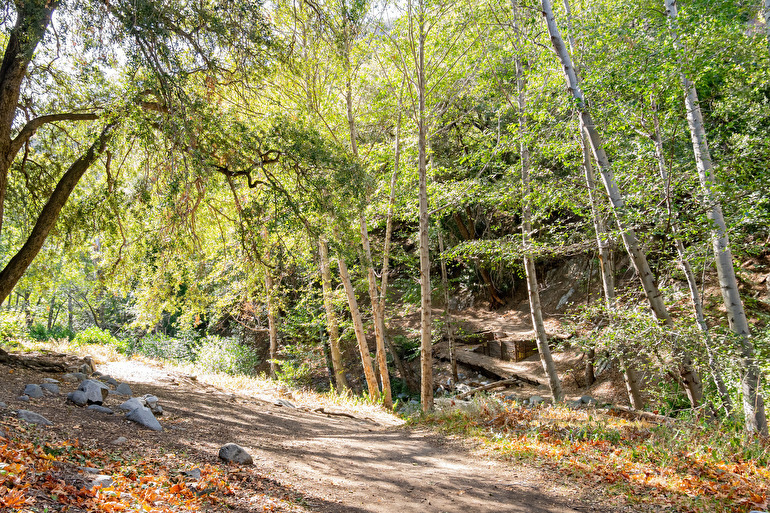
[0,0,770,433]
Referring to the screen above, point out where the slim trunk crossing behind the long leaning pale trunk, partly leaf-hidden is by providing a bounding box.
[564,0,644,410]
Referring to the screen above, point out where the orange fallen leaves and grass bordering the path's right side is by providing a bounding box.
[409,398,770,513]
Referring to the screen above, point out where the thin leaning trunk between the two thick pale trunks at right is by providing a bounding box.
[652,102,733,415]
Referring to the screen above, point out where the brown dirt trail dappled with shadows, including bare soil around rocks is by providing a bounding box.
[0,356,606,513]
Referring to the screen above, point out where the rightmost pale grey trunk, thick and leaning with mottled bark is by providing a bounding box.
[665,0,768,435]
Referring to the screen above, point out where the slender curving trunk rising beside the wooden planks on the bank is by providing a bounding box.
[513,18,564,402]
